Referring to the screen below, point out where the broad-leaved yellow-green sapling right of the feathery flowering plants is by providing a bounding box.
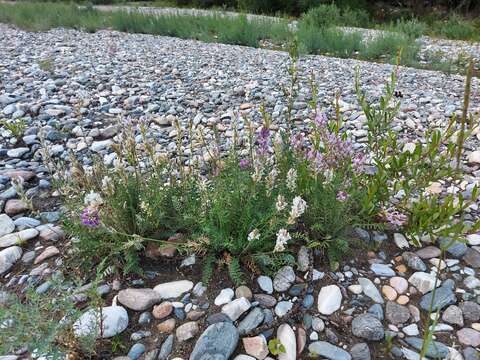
[356,69,480,246]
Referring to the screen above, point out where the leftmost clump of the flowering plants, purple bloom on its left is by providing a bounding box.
[59,119,200,273]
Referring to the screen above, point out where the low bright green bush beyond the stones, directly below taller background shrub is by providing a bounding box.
[297,23,363,58]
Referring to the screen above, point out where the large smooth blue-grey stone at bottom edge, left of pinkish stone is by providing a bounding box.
[189,322,239,360]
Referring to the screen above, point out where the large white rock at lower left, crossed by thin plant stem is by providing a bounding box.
[73,306,128,338]
